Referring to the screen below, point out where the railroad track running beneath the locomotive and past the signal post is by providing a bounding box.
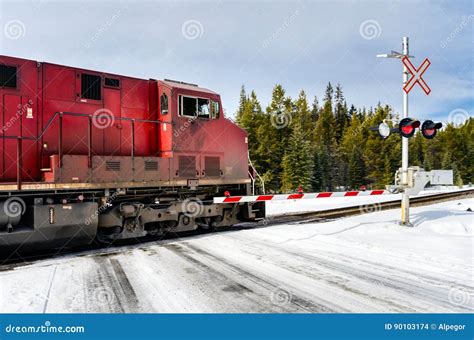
[0,189,474,271]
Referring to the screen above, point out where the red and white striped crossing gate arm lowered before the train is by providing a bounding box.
[214,190,391,203]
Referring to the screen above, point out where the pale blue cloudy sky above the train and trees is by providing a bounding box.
[0,0,474,123]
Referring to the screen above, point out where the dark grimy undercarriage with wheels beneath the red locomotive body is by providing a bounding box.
[0,184,265,252]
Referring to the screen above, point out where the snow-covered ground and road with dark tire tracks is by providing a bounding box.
[0,199,474,313]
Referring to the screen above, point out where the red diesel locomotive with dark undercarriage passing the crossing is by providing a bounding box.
[0,56,265,249]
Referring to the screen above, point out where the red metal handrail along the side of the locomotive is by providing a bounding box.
[0,111,171,190]
